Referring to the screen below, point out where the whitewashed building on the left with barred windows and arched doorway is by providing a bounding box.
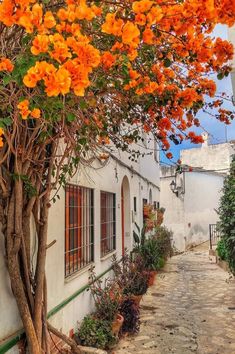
[0,135,160,353]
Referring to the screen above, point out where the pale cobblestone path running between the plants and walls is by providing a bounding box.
[113,251,235,354]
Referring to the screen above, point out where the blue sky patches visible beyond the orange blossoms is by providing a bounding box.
[161,25,235,163]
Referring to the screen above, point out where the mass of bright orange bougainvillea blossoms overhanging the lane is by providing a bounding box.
[0,0,235,153]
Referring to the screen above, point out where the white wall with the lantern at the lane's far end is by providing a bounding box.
[161,167,224,251]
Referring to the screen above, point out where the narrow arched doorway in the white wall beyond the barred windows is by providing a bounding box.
[121,176,131,255]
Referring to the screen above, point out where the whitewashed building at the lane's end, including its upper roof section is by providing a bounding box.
[160,135,235,251]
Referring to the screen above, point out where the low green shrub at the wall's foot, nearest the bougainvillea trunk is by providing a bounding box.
[76,315,117,349]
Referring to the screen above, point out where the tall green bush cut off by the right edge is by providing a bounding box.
[219,156,235,274]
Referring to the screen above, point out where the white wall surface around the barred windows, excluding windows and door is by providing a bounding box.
[0,147,160,353]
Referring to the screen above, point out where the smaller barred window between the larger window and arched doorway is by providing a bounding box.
[100,192,116,257]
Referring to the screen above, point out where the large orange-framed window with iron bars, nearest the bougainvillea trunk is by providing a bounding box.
[65,185,94,277]
